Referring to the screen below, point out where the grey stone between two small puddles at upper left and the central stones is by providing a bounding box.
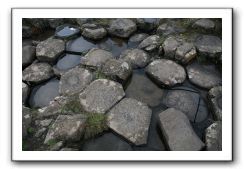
[81,48,113,69]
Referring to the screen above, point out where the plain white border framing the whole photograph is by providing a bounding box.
[12,8,232,161]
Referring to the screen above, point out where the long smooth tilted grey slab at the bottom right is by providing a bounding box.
[159,108,204,151]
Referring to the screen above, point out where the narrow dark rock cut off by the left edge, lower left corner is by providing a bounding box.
[22,106,32,138]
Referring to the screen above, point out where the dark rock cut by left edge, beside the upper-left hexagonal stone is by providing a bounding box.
[22,45,36,67]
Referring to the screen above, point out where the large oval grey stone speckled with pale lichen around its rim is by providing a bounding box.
[146,59,186,87]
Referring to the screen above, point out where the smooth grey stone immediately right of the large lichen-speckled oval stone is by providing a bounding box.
[186,63,222,89]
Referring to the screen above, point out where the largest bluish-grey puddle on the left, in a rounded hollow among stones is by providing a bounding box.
[29,79,59,108]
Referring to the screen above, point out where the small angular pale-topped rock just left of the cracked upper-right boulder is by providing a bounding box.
[138,35,160,52]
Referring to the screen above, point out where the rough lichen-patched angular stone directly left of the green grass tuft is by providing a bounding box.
[44,114,86,144]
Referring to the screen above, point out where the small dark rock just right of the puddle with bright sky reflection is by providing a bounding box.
[82,28,107,40]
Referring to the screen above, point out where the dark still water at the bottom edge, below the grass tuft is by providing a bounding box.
[82,133,132,151]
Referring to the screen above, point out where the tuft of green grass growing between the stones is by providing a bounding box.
[84,113,108,139]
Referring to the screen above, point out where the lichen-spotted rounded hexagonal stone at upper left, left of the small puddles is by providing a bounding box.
[36,38,65,62]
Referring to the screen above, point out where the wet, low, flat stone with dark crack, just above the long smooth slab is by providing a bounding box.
[163,89,208,122]
